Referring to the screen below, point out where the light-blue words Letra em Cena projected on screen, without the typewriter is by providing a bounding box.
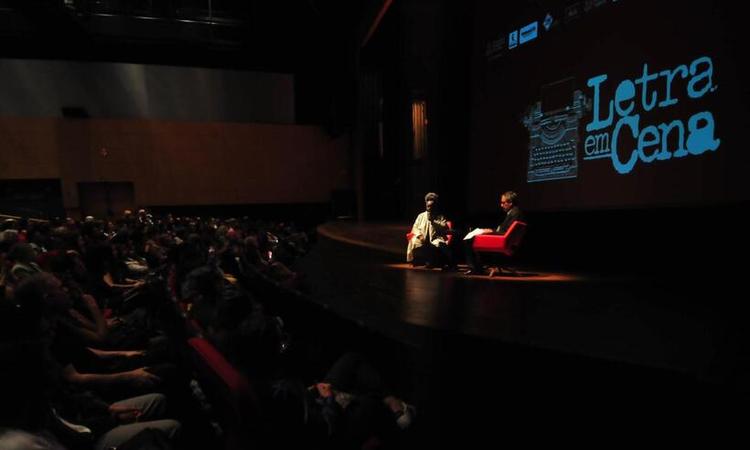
[583,56,721,174]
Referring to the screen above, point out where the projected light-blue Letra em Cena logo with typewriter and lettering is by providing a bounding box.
[523,56,721,183]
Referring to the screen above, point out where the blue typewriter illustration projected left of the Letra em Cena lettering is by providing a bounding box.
[523,78,591,183]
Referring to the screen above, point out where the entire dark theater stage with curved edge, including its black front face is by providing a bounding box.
[299,222,747,446]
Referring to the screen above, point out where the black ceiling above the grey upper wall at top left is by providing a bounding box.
[0,0,373,72]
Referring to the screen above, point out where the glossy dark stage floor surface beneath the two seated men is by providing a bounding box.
[302,222,738,384]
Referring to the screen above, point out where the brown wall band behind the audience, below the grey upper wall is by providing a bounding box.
[0,118,349,217]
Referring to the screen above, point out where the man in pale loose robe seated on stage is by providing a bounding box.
[406,192,453,268]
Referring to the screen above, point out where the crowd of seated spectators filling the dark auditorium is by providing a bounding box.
[0,210,414,449]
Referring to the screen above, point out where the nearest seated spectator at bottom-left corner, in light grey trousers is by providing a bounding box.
[0,274,180,450]
